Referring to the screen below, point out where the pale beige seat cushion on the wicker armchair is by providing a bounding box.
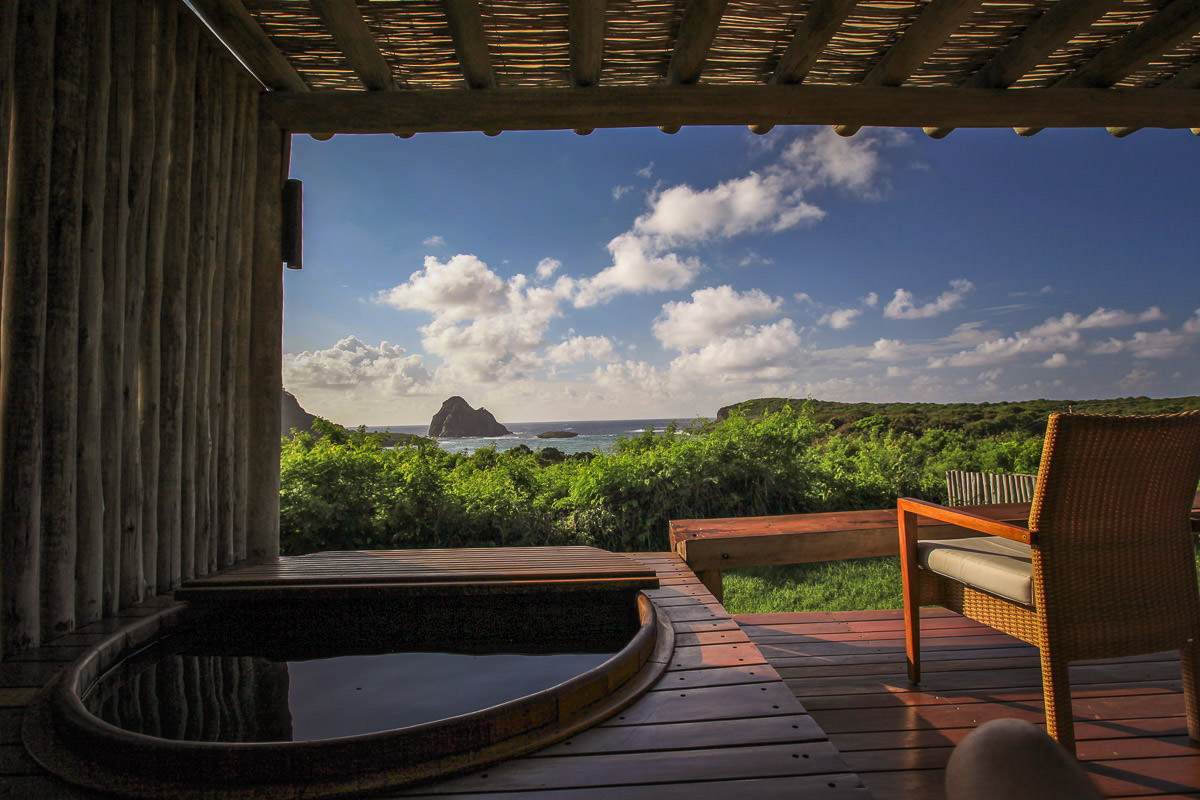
[917,536,1033,606]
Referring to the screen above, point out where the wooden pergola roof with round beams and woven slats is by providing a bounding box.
[191,0,1200,134]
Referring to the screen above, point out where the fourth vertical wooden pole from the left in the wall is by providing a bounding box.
[101,2,133,613]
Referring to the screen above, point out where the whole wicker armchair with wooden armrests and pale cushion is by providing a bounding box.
[898,411,1200,752]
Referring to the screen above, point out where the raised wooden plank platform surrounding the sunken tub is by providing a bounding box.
[0,553,869,800]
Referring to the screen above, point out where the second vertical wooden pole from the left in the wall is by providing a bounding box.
[41,0,88,639]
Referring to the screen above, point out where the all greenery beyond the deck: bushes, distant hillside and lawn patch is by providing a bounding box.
[281,397,1200,614]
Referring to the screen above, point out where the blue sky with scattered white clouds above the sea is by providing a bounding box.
[283,127,1200,425]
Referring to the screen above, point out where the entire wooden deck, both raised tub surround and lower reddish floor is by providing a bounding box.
[0,554,1200,800]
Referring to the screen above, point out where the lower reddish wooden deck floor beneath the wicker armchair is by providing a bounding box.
[736,609,1200,800]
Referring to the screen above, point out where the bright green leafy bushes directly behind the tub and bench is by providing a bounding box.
[281,403,1060,554]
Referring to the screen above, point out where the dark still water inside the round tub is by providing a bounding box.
[83,637,614,742]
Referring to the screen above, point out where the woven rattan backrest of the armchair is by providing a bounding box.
[1030,413,1200,660]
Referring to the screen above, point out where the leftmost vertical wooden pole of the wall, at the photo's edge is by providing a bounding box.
[0,0,54,656]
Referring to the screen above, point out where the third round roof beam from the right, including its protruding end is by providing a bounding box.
[925,0,1121,139]
